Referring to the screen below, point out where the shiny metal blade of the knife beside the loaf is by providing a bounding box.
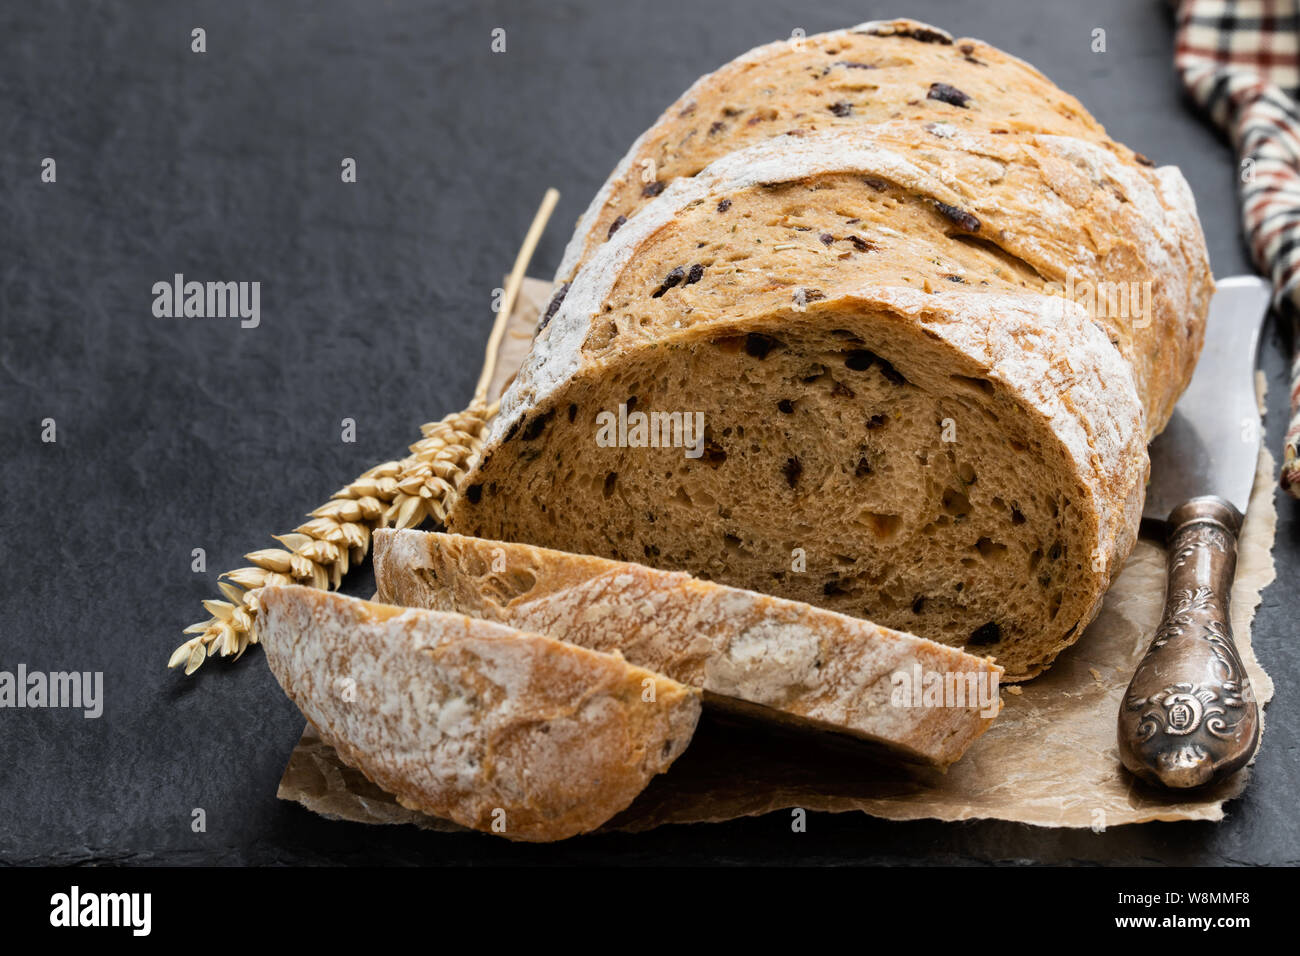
[1143,276,1273,522]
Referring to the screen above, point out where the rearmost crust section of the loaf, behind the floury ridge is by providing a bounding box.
[556,20,1145,284]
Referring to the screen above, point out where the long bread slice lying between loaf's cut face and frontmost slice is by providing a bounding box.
[374,529,1001,766]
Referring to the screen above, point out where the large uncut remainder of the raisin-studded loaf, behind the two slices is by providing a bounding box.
[447,21,1213,680]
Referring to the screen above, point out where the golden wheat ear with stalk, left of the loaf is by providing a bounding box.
[168,189,560,674]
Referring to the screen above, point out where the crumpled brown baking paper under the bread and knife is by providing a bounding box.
[280,280,1277,831]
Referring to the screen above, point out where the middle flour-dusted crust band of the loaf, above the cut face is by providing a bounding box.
[525,122,1213,437]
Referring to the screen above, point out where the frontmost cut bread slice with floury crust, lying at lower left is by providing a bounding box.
[257,587,699,842]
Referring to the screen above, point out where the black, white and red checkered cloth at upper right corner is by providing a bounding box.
[1174,0,1300,498]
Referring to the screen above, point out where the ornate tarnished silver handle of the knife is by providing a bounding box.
[1119,496,1260,788]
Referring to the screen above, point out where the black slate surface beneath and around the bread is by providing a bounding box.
[0,0,1300,864]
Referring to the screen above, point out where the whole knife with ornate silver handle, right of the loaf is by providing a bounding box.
[1119,276,1271,788]
